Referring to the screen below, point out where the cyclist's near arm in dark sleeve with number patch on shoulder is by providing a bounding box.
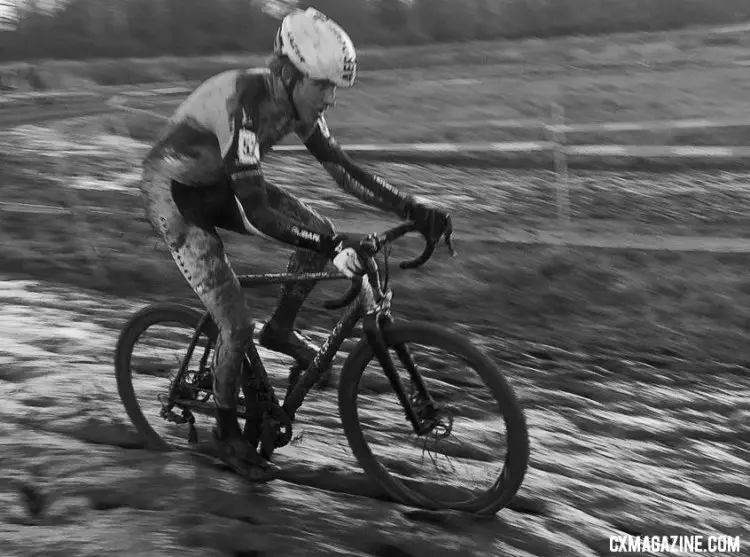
[218,109,334,253]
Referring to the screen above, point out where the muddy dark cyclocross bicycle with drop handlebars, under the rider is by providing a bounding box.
[115,219,529,514]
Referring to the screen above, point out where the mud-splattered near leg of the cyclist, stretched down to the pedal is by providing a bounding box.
[141,168,282,480]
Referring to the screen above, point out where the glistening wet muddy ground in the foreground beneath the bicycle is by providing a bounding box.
[0,281,750,556]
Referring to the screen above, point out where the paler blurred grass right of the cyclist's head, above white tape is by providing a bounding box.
[100,37,750,154]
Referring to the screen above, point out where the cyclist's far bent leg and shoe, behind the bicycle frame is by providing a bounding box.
[260,185,334,367]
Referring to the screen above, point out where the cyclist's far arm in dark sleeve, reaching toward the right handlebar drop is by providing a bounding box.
[297,116,414,218]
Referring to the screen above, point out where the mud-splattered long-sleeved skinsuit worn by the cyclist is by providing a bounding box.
[141,69,412,408]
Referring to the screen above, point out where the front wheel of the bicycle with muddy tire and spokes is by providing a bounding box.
[339,322,529,514]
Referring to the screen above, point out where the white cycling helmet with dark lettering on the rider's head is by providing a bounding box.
[274,8,357,88]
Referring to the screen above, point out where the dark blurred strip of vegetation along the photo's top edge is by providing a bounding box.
[0,0,750,60]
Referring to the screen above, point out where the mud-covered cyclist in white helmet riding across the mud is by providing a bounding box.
[141,8,450,481]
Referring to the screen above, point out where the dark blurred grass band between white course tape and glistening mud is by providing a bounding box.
[0,119,750,365]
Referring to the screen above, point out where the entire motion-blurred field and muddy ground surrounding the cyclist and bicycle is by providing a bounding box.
[0,0,750,557]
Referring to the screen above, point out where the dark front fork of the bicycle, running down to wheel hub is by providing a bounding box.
[362,311,438,436]
